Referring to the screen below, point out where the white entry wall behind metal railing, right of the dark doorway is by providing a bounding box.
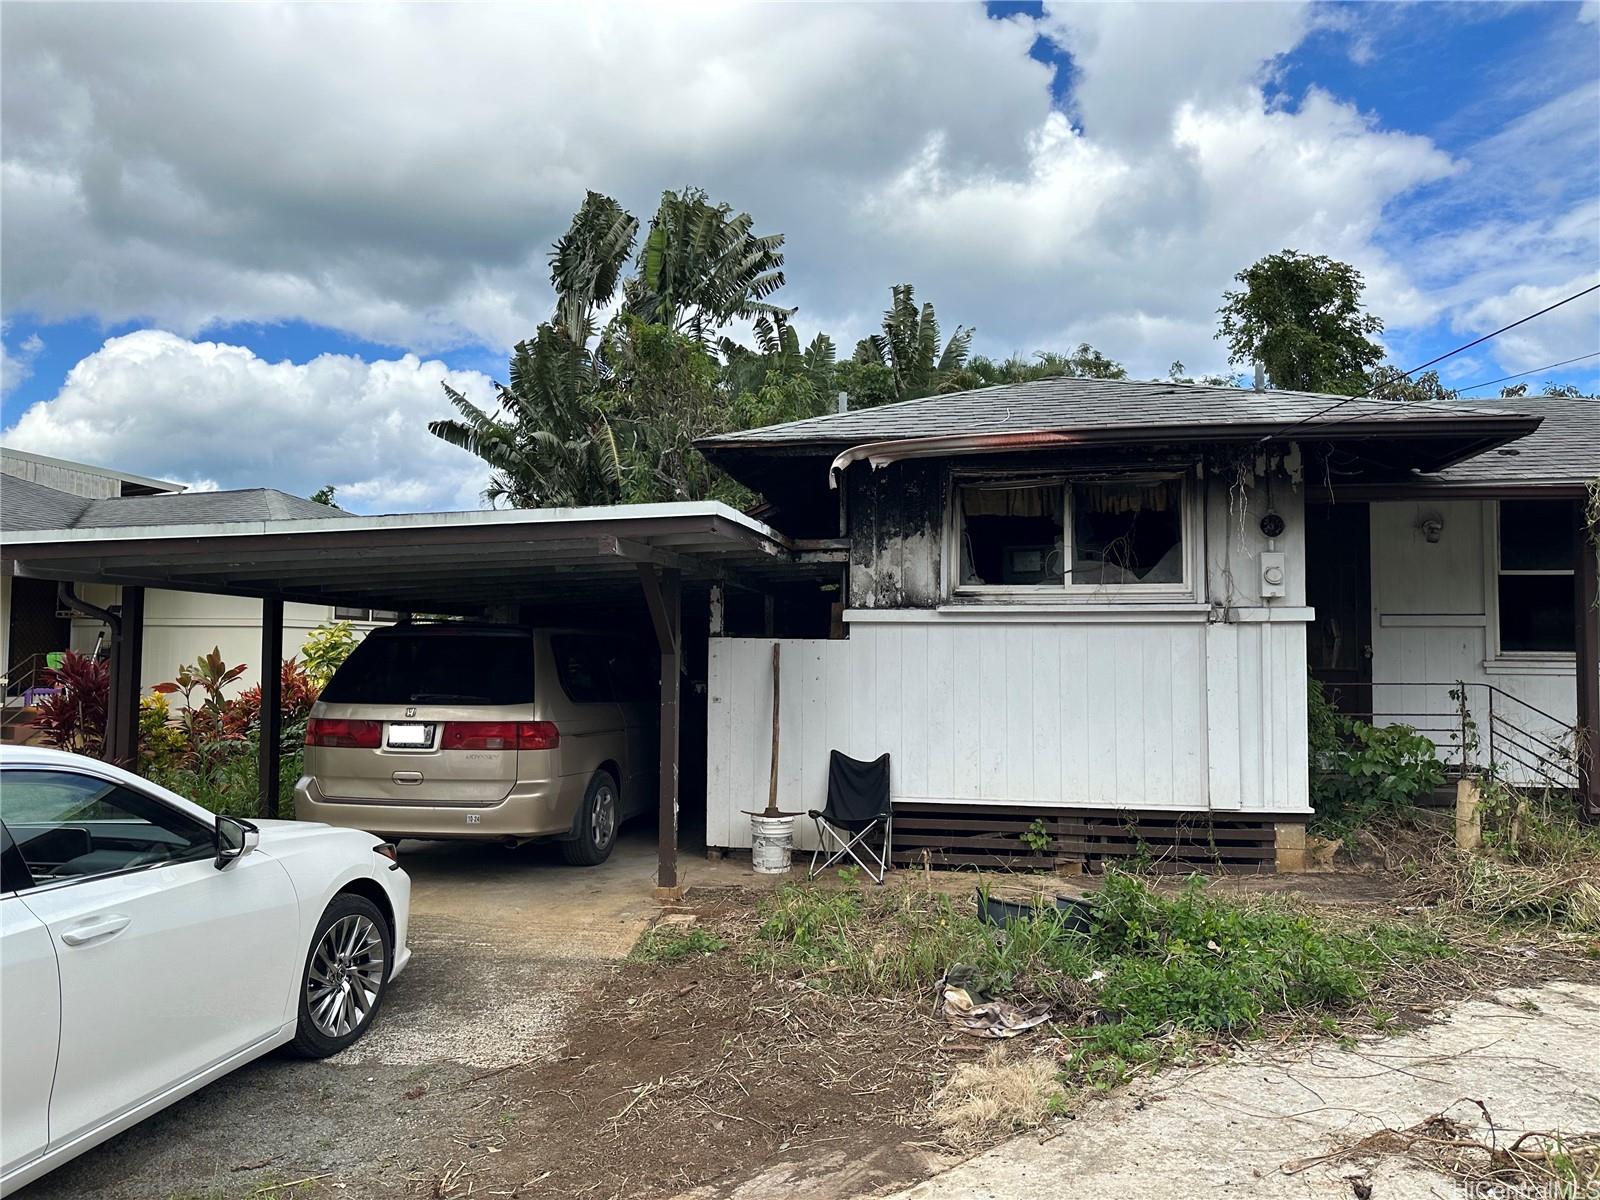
[1371,499,1578,778]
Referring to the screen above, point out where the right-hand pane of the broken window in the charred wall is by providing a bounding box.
[1072,480,1184,586]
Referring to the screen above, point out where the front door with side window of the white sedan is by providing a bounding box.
[0,768,301,1146]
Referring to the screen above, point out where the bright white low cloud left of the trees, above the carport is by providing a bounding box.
[5,330,493,512]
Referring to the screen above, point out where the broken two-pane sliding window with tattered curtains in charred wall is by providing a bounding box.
[955,477,1189,594]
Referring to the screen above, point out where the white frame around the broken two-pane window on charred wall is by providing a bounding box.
[941,469,1205,606]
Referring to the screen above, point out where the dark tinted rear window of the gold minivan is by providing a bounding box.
[322,632,533,704]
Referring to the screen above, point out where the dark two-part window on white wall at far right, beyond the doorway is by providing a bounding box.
[1496,501,1578,654]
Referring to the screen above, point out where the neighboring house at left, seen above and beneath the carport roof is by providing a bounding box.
[0,448,392,688]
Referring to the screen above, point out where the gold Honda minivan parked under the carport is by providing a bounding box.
[294,621,659,866]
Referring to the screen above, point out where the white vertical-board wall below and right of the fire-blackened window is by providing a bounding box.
[707,472,1310,848]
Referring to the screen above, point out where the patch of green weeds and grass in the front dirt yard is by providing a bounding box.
[752,872,1450,1088]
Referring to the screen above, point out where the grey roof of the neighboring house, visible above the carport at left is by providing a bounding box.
[0,475,349,531]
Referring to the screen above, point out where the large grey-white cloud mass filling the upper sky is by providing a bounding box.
[0,3,1595,392]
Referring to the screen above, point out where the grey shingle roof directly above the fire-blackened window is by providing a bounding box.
[699,378,1523,450]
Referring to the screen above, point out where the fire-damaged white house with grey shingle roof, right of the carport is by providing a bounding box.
[701,378,1600,867]
